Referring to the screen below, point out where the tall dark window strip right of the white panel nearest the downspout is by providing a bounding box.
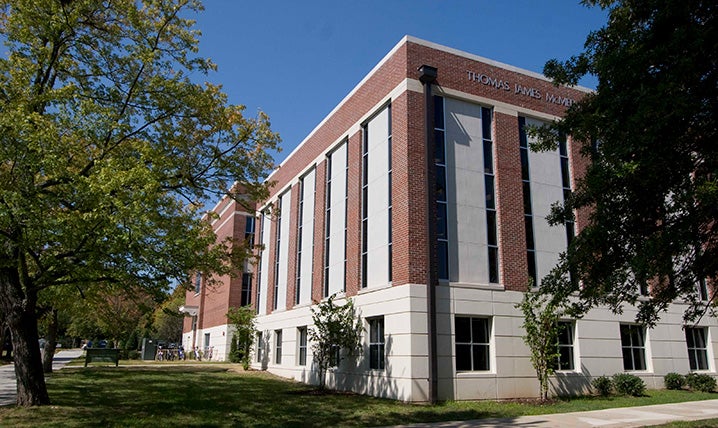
[481,107,499,283]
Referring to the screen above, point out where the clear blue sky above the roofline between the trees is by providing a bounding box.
[191,0,606,163]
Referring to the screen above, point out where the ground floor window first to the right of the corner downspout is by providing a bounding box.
[454,316,491,371]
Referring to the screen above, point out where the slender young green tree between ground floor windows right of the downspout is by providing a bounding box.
[516,271,563,400]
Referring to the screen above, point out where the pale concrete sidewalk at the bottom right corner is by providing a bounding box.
[394,400,718,428]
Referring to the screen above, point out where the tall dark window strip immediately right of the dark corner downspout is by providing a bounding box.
[434,97,449,280]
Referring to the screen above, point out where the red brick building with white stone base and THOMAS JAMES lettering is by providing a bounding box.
[184,37,716,401]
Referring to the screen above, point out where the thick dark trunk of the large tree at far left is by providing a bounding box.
[0,267,50,406]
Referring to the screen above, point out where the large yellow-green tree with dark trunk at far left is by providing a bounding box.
[0,0,279,405]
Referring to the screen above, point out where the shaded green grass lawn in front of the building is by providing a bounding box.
[0,362,718,427]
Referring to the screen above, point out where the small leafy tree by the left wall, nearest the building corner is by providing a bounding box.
[308,294,364,389]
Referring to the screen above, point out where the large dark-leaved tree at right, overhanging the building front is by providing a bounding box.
[536,0,718,326]
